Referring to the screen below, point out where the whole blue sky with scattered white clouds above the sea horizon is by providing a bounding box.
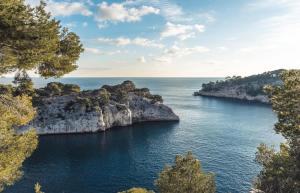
[25,0,300,77]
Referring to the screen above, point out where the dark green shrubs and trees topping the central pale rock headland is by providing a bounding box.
[30,80,163,114]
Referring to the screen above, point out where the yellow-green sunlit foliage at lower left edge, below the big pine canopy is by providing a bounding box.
[0,94,38,191]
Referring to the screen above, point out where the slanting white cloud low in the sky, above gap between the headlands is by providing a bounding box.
[155,46,209,63]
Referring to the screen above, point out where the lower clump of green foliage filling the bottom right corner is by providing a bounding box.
[255,144,300,193]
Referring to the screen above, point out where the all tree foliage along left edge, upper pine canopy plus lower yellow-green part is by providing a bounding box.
[0,0,83,192]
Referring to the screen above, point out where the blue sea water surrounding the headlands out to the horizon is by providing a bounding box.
[0,78,282,193]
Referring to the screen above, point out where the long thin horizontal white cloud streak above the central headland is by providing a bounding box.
[98,37,164,48]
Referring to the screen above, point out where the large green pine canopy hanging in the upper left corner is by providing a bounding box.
[0,0,83,77]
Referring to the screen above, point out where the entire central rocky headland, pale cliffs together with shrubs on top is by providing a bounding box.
[18,81,179,135]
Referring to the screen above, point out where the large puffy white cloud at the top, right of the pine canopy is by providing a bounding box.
[95,2,159,23]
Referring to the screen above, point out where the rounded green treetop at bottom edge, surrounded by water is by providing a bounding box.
[155,152,216,193]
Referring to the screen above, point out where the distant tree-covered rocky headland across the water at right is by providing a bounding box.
[194,69,284,104]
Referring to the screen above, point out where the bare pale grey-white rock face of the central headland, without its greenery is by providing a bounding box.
[17,93,179,135]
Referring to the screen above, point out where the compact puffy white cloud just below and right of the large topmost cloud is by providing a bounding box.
[160,22,205,40]
